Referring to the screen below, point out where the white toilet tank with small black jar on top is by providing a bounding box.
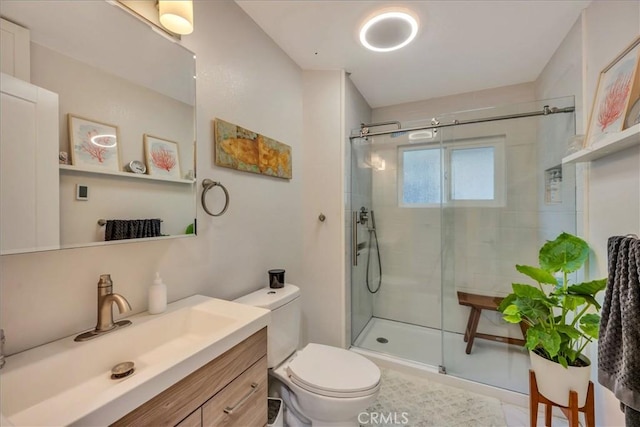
[234,283,300,368]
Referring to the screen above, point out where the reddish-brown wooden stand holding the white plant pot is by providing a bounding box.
[529,369,596,427]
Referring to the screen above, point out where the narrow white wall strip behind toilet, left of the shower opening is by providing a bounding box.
[300,70,347,346]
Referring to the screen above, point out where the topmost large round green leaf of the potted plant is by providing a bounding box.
[538,233,589,273]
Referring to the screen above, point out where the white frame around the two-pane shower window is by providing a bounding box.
[397,135,506,208]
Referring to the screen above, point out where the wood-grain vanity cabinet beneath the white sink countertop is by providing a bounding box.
[112,328,267,427]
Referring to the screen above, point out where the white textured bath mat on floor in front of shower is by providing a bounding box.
[358,369,507,427]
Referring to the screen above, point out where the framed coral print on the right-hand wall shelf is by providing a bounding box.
[585,37,640,147]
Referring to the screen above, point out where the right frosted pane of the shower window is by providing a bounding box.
[450,147,495,200]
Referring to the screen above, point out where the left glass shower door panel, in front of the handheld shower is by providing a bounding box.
[350,123,442,366]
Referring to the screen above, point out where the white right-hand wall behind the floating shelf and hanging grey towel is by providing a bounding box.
[536,1,640,426]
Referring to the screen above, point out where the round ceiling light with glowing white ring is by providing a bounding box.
[360,11,418,52]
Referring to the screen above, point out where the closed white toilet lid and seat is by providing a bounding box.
[287,344,380,397]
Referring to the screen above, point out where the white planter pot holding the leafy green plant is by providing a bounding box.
[529,351,591,408]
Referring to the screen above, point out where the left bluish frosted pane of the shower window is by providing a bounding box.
[401,148,441,205]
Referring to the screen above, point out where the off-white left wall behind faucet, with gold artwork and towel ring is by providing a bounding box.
[0,1,304,354]
